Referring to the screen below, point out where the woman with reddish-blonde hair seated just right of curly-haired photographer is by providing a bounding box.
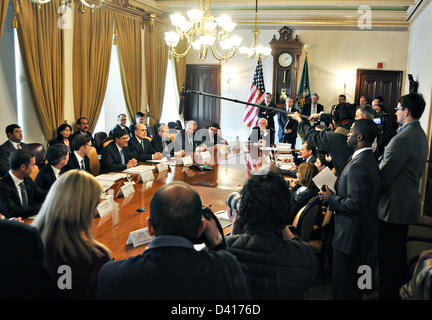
[288,162,319,224]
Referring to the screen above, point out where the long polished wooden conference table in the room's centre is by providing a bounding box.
[93,144,286,260]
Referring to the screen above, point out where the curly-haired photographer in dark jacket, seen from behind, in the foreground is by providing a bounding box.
[226,167,318,299]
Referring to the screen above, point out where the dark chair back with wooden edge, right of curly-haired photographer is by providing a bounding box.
[293,197,321,241]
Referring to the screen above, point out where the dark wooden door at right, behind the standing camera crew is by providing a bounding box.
[355,69,403,113]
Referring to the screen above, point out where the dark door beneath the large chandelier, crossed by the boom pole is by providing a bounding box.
[184,64,221,127]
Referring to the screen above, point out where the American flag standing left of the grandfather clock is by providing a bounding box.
[243,57,265,128]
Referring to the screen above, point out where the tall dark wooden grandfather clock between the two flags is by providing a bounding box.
[270,26,303,108]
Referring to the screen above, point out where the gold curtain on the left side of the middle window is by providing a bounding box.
[73,6,113,131]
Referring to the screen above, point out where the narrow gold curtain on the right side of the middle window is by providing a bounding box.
[116,15,142,119]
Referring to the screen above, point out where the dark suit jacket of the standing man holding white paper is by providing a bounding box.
[328,150,381,255]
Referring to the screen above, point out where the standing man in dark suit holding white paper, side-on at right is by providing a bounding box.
[319,119,381,300]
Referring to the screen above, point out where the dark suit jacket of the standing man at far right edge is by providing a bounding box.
[378,121,428,224]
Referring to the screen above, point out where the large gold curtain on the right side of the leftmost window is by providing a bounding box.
[14,0,64,139]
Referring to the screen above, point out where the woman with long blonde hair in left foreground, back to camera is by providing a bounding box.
[32,170,112,299]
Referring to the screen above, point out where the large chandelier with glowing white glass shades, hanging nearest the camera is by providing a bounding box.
[165,0,242,62]
